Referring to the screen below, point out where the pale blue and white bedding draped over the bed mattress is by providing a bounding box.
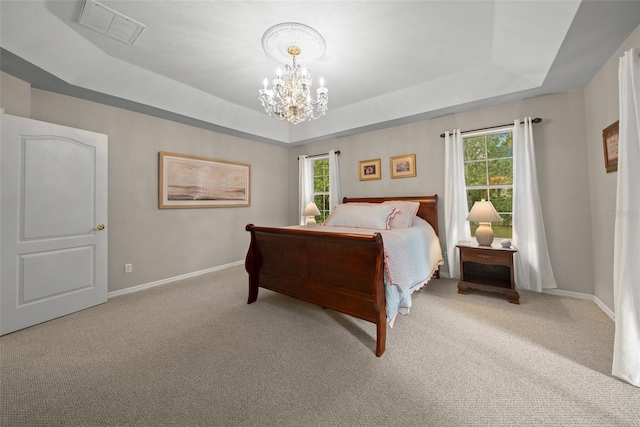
[291,217,444,327]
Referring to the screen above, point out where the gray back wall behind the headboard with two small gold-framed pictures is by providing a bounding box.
[289,90,593,294]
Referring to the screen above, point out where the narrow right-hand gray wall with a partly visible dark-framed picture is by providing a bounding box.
[584,27,640,311]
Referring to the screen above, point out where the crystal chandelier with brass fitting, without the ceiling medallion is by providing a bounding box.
[259,46,329,125]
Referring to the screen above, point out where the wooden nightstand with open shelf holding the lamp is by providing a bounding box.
[457,242,520,304]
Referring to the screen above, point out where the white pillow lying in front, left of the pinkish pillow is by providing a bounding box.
[324,203,396,230]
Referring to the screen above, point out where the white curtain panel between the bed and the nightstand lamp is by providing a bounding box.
[444,129,471,279]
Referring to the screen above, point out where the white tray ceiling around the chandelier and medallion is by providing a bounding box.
[0,0,640,146]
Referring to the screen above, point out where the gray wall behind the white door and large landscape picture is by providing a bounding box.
[1,73,289,291]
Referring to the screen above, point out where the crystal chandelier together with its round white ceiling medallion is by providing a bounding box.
[258,22,329,124]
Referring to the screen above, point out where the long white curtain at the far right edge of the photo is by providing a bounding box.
[611,49,640,387]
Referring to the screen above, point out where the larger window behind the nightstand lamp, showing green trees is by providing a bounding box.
[463,129,513,238]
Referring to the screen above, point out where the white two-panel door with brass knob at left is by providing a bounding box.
[0,114,107,335]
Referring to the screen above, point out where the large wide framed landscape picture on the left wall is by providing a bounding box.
[158,151,251,209]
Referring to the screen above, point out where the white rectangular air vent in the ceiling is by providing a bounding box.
[78,0,146,45]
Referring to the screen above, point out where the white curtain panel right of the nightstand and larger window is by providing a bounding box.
[513,117,558,292]
